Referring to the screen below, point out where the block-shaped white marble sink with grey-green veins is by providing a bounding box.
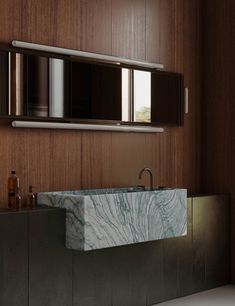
[38,188,187,251]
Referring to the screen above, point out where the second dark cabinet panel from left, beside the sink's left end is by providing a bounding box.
[29,210,72,306]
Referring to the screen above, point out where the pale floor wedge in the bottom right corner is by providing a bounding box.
[155,285,235,306]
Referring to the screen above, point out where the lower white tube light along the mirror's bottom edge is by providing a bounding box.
[11,121,164,133]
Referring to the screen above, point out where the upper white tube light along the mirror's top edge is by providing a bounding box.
[12,40,164,69]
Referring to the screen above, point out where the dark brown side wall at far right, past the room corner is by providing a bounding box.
[202,0,235,282]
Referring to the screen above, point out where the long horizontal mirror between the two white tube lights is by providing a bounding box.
[0,51,182,125]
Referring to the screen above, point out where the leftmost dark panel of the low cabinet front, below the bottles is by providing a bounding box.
[0,213,28,306]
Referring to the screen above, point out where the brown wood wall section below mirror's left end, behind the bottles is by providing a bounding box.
[0,127,82,207]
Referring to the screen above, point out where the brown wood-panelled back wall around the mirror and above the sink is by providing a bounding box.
[0,0,201,207]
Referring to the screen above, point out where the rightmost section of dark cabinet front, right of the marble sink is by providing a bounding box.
[193,196,230,292]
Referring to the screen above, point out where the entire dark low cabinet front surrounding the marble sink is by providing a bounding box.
[0,195,229,306]
